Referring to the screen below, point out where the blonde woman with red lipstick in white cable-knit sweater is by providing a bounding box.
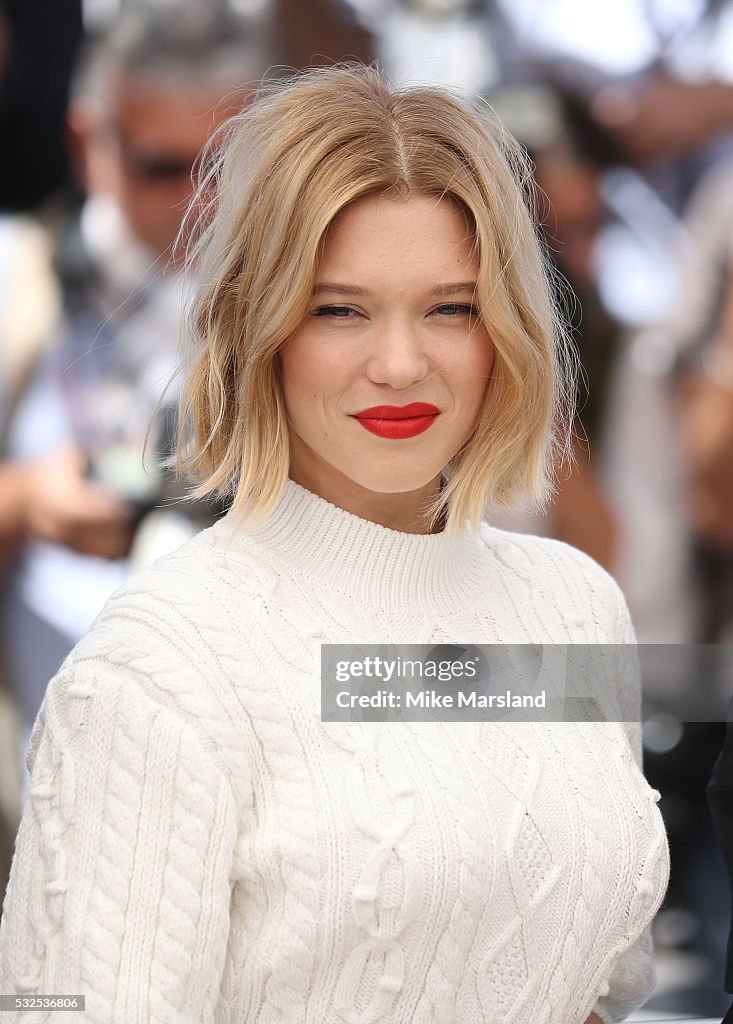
[0,67,667,1024]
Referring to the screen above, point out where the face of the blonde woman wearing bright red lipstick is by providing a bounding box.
[281,196,493,518]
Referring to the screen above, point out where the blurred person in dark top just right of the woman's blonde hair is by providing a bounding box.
[483,96,618,571]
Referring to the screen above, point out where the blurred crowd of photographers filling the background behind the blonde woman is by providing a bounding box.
[0,0,733,1016]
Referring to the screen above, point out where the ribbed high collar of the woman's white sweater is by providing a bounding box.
[215,480,489,615]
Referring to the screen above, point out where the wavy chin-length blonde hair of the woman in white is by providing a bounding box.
[178,63,574,532]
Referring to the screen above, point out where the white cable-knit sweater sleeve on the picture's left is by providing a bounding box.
[0,658,236,1024]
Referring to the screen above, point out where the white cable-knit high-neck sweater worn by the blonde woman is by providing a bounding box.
[0,482,669,1024]
